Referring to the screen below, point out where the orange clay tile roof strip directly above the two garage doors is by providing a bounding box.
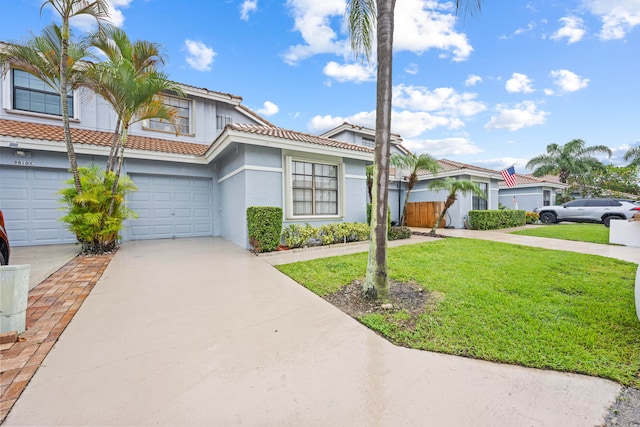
[0,120,208,156]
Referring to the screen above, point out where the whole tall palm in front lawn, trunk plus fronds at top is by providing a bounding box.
[347,0,482,299]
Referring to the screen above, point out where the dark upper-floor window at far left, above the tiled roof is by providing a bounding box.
[12,69,74,117]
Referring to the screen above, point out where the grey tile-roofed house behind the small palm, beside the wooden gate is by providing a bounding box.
[389,159,502,228]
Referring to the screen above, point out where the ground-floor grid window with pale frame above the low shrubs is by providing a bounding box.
[291,160,338,216]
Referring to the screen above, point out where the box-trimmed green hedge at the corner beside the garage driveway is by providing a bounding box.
[247,206,282,253]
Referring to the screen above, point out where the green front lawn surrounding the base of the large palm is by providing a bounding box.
[278,239,640,388]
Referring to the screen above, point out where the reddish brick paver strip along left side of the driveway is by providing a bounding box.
[0,255,113,423]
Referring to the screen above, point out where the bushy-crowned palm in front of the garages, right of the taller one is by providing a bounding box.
[83,28,182,214]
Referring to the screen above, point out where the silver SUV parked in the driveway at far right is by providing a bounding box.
[534,199,640,227]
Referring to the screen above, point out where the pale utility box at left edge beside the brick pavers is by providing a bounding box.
[0,264,31,334]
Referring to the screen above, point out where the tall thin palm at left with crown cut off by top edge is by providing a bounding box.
[40,0,109,194]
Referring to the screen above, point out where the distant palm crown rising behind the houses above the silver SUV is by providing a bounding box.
[526,139,612,184]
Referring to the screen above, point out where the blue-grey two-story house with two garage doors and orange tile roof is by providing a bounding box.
[0,66,373,247]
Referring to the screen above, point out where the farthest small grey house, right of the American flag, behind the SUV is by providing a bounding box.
[498,173,567,212]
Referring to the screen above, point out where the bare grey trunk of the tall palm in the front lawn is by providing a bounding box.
[362,0,395,299]
